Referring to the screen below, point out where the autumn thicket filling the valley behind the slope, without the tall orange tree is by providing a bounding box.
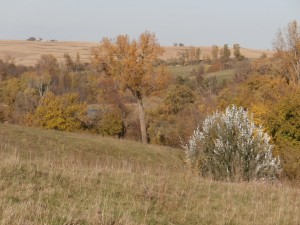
[0,20,300,179]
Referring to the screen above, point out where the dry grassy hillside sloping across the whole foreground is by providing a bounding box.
[0,124,300,225]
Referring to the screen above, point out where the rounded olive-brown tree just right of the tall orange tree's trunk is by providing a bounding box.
[148,84,200,147]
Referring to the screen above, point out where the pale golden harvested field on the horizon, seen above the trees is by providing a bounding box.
[0,40,273,66]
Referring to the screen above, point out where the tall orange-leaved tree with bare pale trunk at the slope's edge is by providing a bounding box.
[92,31,167,143]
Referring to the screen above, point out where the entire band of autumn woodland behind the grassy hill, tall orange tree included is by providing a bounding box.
[0,21,300,180]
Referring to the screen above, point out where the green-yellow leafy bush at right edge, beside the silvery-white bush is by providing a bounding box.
[265,90,300,179]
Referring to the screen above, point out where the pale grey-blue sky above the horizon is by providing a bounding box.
[0,0,300,51]
